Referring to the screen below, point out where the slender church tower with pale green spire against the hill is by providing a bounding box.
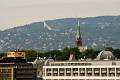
[75,21,82,48]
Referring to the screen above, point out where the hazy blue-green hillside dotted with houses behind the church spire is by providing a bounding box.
[0,16,120,51]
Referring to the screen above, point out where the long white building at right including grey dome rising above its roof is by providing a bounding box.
[43,51,120,80]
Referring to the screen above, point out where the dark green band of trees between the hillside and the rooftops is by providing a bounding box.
[0,48,120,61]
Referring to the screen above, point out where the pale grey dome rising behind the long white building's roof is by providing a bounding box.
[96,50,115,60]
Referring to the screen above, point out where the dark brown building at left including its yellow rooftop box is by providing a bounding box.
[0,51,37,80]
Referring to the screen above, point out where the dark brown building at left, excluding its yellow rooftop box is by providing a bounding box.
[0,58,37,80]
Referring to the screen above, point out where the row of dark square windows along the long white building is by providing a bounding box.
[44,68,120,76]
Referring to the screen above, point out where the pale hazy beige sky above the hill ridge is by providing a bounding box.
[0,0,120,30]
